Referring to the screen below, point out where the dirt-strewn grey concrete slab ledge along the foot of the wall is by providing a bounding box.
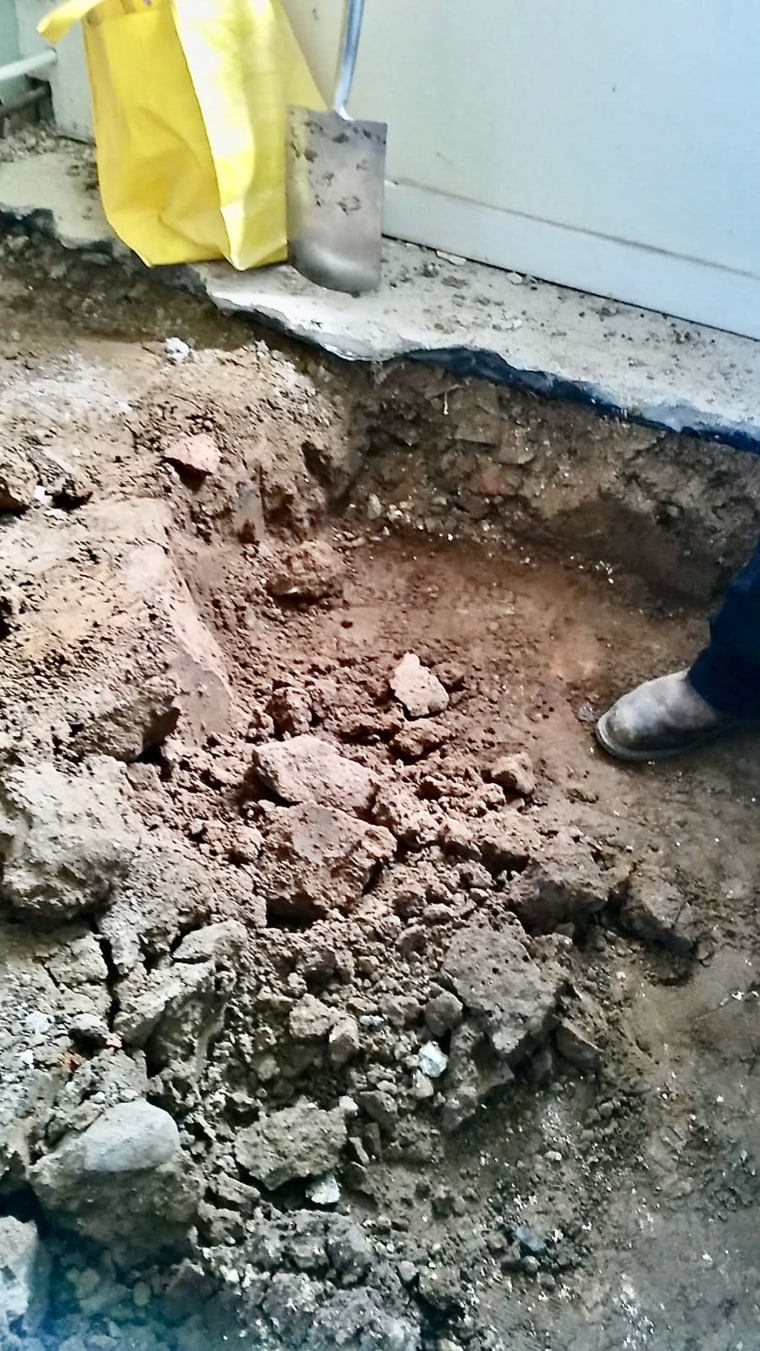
[0,138,760,453]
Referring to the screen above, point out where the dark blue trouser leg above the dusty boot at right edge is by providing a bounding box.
[688,540,760,717]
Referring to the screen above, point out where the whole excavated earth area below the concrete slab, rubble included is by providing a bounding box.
[0,236,760,1351]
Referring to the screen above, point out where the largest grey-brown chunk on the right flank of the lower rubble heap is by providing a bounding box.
[443,925,562,1067]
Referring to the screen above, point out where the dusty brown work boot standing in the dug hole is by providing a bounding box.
[597,671,756,761]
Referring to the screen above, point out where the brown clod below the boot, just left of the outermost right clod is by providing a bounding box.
[509,846,612,934]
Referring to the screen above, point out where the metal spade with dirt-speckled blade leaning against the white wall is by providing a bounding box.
[288,0,387,295]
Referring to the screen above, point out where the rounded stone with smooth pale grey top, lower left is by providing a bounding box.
[30,1100,196,1266]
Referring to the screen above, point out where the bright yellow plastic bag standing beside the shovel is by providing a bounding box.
[39,0,324,269]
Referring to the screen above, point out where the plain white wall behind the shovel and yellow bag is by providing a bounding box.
[285,0,760,336]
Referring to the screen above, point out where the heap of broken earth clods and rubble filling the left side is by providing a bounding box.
[0,386,697,1351]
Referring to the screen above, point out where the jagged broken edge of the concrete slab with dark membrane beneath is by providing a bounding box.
[0,201,760,454]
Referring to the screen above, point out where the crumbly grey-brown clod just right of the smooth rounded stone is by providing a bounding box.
[235,1098,347,1192]
